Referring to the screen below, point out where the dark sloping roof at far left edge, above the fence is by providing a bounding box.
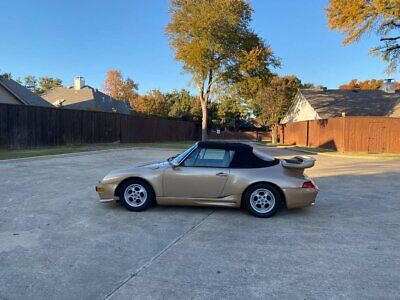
[0,78,54,107]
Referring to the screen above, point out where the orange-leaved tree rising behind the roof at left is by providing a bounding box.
[102,70,139,102]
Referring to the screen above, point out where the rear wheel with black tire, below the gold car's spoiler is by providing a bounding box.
[243,183,282,218]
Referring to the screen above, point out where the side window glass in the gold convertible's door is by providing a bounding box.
[183,148,234,168]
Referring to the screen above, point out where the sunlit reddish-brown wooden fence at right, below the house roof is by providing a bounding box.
[280,117,400,153]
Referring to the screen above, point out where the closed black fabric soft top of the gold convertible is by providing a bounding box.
[197,141,279,169]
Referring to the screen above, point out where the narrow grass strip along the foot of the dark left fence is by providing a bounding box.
[0,141,195,160]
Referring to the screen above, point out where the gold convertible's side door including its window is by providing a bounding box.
[163,148,233,198]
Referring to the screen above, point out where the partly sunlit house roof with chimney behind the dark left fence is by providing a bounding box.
[43,86,131,114]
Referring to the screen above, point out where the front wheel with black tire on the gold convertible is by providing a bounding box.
[118,179,156,211]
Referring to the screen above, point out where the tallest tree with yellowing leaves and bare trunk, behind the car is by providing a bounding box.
[166,0,278,140]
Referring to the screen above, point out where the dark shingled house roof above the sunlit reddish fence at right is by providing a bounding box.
[300,89,400,119]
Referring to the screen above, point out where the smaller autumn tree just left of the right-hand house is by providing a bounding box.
[254,76,302,143]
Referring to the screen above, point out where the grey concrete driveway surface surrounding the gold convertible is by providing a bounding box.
[0,147,400,299]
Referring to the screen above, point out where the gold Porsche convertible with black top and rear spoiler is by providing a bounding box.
[96,142,318,218]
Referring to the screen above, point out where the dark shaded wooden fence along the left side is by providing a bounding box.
[0,104,199,149]
